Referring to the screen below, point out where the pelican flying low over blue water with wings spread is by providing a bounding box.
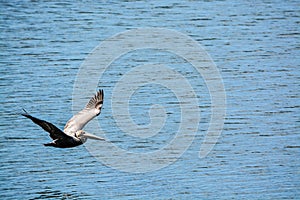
[22,90,104,148]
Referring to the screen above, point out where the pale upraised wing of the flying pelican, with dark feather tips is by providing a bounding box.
[64,90,104,135]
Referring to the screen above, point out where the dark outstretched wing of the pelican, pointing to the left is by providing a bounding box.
[22,113,70,140]
